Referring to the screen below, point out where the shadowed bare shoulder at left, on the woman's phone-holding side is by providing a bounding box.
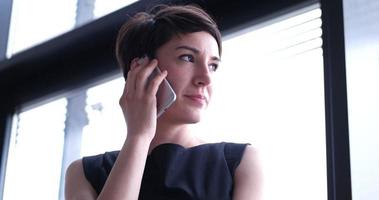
[65,159,97,200]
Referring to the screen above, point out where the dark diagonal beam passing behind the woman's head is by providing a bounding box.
[0,0,316,105]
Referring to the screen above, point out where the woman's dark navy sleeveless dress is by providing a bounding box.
[83,142,247,200]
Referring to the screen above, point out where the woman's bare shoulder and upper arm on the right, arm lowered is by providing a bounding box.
[233,145,263,200]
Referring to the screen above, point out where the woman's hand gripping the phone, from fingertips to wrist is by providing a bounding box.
[119,56,167,140]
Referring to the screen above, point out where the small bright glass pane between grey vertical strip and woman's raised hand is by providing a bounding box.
[81,78,126,156]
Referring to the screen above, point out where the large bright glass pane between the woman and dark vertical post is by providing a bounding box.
[197,5,327,200]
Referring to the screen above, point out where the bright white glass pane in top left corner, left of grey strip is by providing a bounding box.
[7,0,76,58]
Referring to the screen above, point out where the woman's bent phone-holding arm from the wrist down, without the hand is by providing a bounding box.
[65,138,150,200]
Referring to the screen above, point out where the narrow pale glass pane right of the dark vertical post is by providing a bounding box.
[343,0,379,200]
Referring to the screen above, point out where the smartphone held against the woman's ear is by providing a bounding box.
[148,66,176,117]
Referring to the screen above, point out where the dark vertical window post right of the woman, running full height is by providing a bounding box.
[321,0,352,200]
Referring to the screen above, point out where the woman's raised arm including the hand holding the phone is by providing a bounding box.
[66,58,167,200]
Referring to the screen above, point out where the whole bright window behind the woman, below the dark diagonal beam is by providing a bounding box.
[4,5,327,200]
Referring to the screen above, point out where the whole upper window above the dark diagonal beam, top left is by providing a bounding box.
[7,0,137,58]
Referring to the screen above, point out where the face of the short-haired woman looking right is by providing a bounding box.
[156,32,220,123]
